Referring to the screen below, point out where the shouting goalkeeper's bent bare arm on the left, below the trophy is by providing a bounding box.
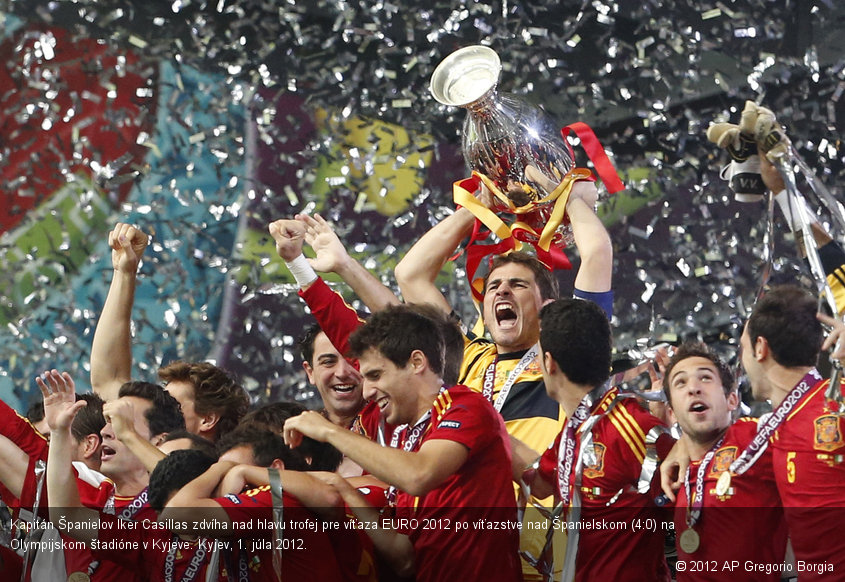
[395,208,475,314]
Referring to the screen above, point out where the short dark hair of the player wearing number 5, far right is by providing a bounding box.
[747,285,824,368]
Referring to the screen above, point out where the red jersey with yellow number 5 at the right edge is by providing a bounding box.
[771,380,845,581]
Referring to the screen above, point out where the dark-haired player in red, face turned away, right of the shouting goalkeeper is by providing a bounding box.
[514,299,672,582]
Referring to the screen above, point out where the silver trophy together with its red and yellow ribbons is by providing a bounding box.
[430,45,623,299]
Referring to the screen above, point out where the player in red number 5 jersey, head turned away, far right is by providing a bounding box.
[741,286,845,581]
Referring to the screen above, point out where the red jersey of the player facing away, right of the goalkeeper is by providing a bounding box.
[538,389,673,582]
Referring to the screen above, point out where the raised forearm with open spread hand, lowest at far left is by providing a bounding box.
[36,370,99,544]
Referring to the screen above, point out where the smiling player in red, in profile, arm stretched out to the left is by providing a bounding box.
[285,306,521,582]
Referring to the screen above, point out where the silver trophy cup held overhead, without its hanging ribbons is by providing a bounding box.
[430,45,575,245]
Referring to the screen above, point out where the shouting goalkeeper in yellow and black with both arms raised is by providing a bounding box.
[396,181,613,580]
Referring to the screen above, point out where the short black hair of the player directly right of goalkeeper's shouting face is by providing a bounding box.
[540,299,612,386]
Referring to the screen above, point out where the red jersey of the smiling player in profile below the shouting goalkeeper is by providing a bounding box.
[396,386,522,582]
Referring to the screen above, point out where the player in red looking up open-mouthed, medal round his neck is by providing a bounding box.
[663,344,786,582]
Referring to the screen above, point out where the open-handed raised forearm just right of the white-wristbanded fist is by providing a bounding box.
[296,214,399,312]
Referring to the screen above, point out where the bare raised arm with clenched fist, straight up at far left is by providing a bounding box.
[91,223,149,401]
